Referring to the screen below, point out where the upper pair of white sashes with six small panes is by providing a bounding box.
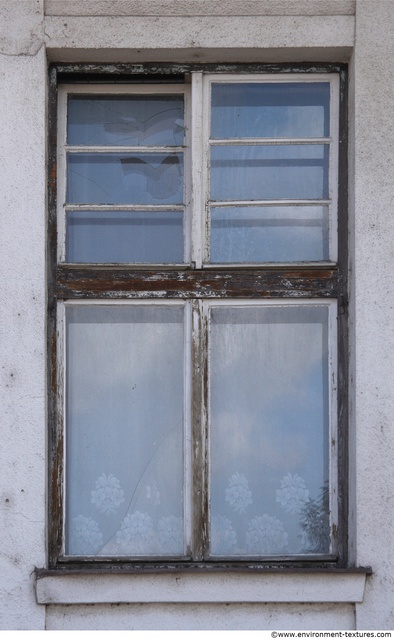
[58,72,339,268]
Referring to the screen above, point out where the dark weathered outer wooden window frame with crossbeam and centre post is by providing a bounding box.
[47,64,348,571]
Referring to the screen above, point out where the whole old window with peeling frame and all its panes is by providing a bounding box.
[49,65,346,566]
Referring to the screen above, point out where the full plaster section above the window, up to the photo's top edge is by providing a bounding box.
[41,0,355,62]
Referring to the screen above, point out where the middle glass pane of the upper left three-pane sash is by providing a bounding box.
[67,153,183,204]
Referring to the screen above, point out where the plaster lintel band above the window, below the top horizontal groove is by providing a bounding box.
[45,15,354,62]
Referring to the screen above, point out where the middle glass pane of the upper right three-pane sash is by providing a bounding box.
[211,144,328,201]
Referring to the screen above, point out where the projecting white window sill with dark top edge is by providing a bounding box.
[36,568,371,604]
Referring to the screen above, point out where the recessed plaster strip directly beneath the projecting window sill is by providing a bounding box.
[47,604,354,630]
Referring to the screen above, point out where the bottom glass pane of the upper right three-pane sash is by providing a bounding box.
[210,206,329,263]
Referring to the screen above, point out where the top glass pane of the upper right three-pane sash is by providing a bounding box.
[211,82,330,139]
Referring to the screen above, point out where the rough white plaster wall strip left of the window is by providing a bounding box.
[0,2,46,629]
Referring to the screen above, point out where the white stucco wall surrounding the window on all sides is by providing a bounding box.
[0,0,394,629]
